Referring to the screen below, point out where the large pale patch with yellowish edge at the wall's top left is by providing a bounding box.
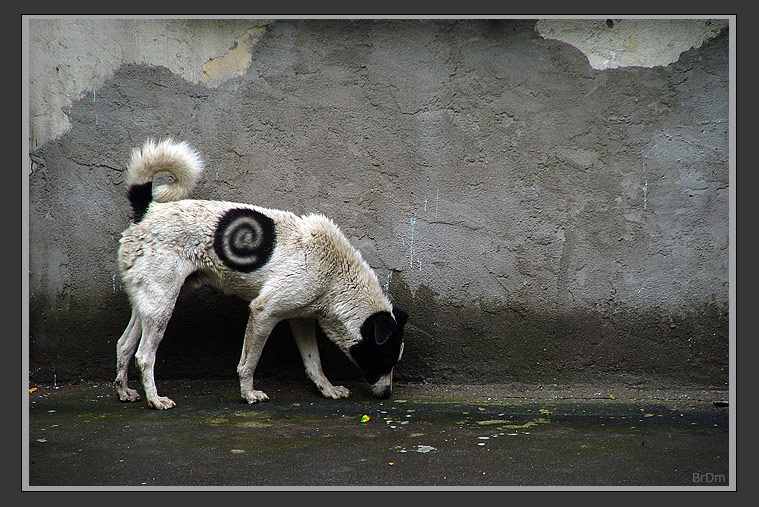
[27,18,273,149]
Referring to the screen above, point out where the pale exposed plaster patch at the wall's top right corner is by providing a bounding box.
[535,19,729,70]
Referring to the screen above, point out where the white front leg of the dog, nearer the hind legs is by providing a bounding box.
[237,299,277,403]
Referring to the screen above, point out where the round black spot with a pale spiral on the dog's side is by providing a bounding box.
[213,208,276,273]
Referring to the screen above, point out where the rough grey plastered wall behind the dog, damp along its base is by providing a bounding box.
[29,19,729,386]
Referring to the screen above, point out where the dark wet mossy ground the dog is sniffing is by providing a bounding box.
[24,379,730,490]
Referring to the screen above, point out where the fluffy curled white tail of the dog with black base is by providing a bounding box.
[127,139,203,222]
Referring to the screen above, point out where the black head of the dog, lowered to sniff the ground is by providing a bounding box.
[350,308,408,398]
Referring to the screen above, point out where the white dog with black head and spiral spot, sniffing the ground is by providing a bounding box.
[115,139,408,409]
